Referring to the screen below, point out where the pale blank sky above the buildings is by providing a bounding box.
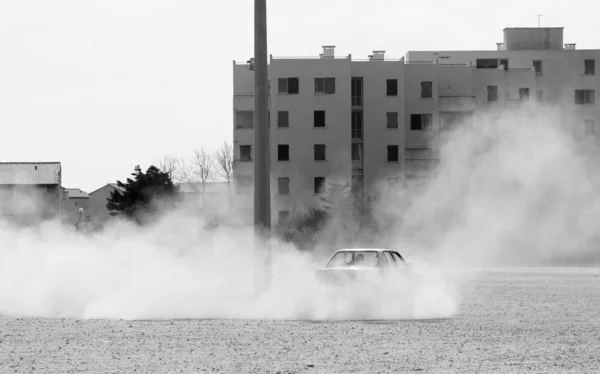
[0,0,600,192]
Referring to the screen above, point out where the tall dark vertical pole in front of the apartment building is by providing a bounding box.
[254,0,271,291]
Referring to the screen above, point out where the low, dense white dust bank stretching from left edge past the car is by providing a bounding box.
[0,191,456,319]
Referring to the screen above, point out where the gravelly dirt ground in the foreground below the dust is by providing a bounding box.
[0,268,600,373]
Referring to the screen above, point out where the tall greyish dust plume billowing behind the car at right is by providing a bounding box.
[379,107,600,267]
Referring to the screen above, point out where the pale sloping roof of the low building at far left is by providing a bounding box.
[0,162,61,185]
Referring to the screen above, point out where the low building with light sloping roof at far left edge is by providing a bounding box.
[0,162,63,224]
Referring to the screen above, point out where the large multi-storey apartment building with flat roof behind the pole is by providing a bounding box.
[233,28,600,224]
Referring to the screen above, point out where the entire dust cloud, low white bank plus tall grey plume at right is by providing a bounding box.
[0,108,600,319]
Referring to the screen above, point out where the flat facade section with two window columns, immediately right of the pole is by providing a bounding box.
[270,59,351,223]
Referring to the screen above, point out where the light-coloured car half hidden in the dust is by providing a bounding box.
[316,248,411,284]
